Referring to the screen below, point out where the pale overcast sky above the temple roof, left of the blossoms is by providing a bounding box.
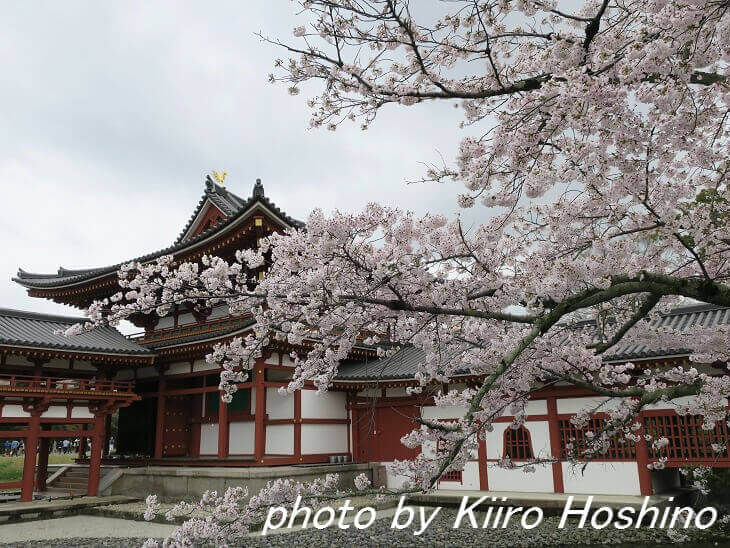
[0,0,482,322]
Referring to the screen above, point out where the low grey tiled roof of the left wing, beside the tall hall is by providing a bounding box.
[0,308,154,356]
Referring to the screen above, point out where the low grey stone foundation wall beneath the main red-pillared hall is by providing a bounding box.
[102,463,382,500]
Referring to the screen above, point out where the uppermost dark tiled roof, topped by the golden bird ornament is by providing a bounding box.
[13,180,304,289]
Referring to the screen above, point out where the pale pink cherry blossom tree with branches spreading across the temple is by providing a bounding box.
[68,0,730,544]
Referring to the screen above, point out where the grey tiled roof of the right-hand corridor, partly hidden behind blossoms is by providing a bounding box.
[335,304,730,381]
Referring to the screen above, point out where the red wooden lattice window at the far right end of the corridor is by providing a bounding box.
[644,412,728,460]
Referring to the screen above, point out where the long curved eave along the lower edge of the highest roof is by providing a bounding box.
[12,200,298,296]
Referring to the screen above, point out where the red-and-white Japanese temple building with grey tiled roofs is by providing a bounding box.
[0,178,730,500]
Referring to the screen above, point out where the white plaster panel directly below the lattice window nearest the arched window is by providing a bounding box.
[556,462,641,495]
